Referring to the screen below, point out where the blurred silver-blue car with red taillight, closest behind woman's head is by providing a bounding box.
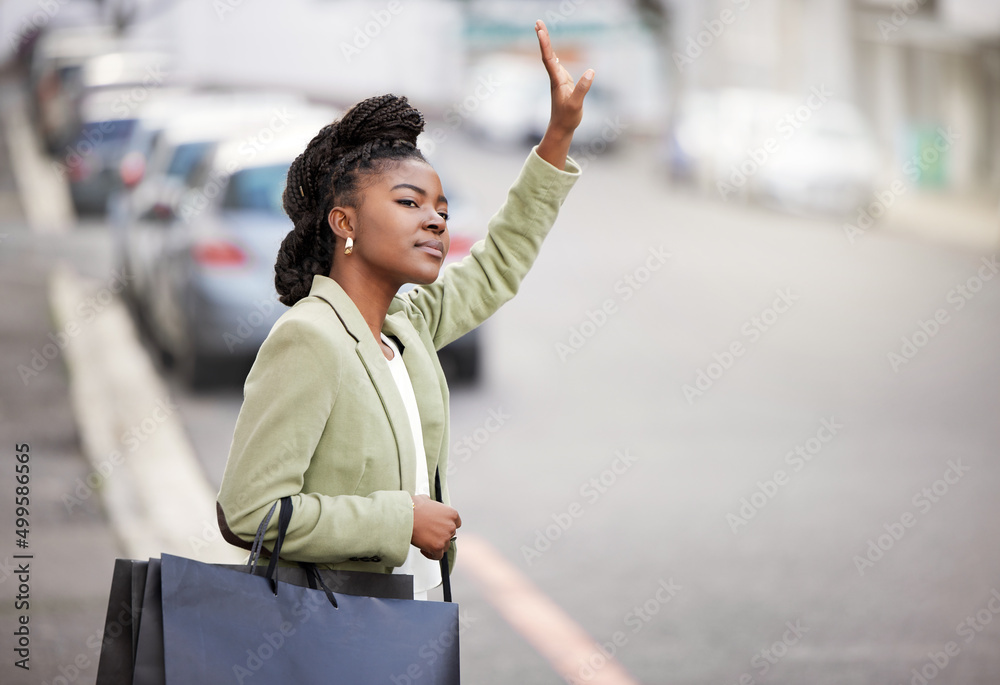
[133,105,336,386]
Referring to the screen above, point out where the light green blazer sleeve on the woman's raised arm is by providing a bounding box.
[401,148,580,349]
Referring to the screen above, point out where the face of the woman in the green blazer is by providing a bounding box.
[347,159,449,288]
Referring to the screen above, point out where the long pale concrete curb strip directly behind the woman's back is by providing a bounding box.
[49,265,246,563]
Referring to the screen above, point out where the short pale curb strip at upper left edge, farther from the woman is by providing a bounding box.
[2,93,75,233]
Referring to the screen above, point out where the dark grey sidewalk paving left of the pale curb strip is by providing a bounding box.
[0,255,123,685]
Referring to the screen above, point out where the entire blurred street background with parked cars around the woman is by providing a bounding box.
[0,0,1000,685]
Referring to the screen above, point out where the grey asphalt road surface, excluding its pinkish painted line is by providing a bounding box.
[164,136,1000,685]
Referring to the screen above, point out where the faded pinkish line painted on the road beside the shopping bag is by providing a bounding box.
[459,533,637,685]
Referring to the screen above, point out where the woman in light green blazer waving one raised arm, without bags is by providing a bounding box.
[218,21,593,598]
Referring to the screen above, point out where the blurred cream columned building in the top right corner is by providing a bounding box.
[854,0,1000,191]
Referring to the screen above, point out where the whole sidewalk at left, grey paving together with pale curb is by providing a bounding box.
[0,68,243,685]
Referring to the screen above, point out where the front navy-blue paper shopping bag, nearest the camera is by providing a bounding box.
[161,554,459,685]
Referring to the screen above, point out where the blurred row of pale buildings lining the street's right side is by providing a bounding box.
[665,0,1000,194]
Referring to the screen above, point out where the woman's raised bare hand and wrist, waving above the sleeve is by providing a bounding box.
[535,19,594,169]
